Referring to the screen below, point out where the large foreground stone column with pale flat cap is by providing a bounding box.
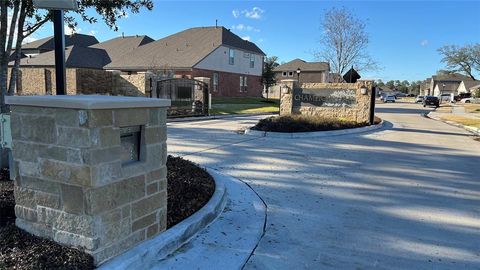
[7,96,170,264]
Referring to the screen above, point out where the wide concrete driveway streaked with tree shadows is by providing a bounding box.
[168,103,480,269]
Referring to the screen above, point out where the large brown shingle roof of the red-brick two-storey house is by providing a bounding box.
[105,27,265,70]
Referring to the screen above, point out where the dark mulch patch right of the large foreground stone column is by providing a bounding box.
[167,156,215,228]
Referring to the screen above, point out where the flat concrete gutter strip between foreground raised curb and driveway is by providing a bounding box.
[148,168,268,270]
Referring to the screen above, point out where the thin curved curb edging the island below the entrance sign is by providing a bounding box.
[245,120,385,139]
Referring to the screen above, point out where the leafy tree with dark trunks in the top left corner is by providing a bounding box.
[0,0,153,112]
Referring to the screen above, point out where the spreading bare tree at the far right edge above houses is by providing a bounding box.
[438,43,480,80]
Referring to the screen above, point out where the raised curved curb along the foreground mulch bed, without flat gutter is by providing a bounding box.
[98,170,227,270]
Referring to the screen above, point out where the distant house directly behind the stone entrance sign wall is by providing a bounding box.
[274,58,330,85]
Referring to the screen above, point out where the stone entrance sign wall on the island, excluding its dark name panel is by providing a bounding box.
[280,80,373,122]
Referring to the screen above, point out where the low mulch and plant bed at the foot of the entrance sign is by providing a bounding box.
[252,115,381,132]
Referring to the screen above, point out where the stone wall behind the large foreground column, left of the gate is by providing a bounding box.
[9,67,155,97]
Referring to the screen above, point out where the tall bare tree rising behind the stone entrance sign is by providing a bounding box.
[315,8,377,75]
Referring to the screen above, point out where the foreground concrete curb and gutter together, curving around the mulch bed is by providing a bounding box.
[99,169,266,269]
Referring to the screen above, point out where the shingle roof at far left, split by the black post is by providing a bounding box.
[14,46,110,69]
